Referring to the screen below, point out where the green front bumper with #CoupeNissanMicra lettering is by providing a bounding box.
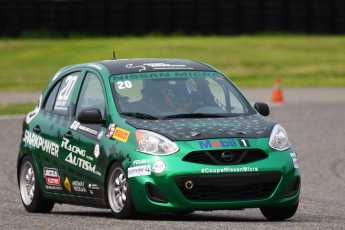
[129,148,300,212]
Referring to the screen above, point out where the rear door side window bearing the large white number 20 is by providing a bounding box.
[54,72,79,114]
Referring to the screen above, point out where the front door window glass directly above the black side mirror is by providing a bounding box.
[76,73,105,117]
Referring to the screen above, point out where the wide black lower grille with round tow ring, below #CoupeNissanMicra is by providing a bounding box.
[175,172,281,202]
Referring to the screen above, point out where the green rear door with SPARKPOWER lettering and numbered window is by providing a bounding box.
[26,71,80,193]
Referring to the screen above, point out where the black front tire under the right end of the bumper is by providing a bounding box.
[260,202,298,221]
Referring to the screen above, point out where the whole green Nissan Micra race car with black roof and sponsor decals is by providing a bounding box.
[17,59,300,220]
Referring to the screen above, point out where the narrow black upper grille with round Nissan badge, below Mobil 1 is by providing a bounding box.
[182,149,267,165]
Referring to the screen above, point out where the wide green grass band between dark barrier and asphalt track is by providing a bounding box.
[0,35,345,91]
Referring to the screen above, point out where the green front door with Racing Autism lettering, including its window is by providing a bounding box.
[60,71,106,198]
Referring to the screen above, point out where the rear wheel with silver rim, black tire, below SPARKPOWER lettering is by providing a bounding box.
[18,156,54,213]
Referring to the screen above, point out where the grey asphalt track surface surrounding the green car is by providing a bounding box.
[0,88,345,230]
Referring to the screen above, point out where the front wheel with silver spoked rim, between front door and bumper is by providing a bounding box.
[107,162,138,219]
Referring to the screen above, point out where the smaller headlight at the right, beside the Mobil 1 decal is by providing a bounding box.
[269,124,291,151]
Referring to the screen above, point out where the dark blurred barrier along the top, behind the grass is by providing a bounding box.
[0,0,345,36]
